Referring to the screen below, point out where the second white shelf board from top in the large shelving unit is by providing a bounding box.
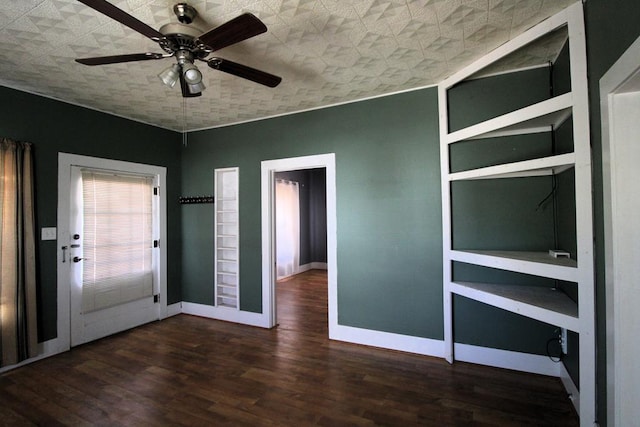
[449,153,575,181]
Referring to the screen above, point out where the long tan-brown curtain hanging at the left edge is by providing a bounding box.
[0,139,38,366]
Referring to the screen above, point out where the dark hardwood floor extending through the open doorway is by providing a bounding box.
[0,270,578,426]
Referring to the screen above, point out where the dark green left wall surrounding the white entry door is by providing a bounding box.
[0,86,181,340]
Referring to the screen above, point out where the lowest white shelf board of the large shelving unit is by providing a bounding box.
[449,282,580,332]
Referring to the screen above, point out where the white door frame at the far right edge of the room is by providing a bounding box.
[600,34,640,426]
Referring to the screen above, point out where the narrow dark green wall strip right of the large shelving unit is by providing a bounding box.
[585,0,640,425]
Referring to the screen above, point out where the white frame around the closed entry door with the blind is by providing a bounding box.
[57,153,167,348]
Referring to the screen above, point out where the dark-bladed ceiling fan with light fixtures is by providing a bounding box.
[76,0,282,98]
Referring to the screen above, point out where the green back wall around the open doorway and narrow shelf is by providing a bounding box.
[182,74,552,354]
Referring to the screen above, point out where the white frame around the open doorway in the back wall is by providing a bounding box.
[261,153,338,338]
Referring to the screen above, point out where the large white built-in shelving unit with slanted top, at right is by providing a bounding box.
[438,2,596,426]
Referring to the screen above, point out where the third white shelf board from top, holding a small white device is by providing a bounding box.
[450,250,578,282]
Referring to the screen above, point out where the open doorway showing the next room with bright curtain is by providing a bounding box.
[275,168,328,336]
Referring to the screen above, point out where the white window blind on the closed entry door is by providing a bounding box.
[82,170,153,312]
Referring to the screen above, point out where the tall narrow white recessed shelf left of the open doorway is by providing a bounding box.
[214,168,240,309]
